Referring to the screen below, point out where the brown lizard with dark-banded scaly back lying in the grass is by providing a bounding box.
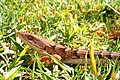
[18,32,120,64]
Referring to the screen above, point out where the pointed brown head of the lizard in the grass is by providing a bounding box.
[17,32,47,52]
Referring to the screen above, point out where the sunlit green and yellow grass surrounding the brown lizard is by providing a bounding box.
[0,0,120,80]
